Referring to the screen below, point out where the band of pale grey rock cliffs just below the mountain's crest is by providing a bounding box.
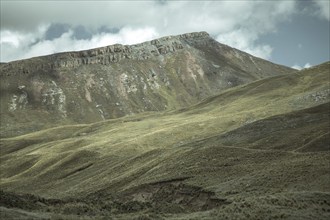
[3,32,210,74]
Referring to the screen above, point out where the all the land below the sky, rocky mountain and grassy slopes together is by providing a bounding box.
[0,33,330,220]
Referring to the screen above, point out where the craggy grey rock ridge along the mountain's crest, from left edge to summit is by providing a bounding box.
[2,32,210,73]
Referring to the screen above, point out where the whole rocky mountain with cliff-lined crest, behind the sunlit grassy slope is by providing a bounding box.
[0,32,294,136]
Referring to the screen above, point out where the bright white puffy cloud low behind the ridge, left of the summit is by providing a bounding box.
[1,27,158,62]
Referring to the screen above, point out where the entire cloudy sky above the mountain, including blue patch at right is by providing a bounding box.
[0,0,330,69]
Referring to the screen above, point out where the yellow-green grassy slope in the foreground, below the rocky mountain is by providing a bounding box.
[1,63,330,219]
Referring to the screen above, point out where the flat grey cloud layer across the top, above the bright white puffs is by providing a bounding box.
[1,0,292,35]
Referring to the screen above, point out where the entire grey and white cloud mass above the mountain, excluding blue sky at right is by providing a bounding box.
[0,0,296,61]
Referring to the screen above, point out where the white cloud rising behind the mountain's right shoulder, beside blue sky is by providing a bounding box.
[216,1,296,59]
